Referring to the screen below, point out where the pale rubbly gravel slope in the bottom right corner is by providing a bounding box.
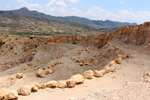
[73,82,150,100]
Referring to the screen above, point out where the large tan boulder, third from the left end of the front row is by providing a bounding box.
[17,85,32,96]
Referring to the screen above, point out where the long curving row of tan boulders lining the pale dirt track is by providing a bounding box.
[0,55,129,100]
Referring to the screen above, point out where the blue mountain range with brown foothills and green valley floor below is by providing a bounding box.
[0,7,137,34]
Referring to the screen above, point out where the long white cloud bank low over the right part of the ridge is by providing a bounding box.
[46,7,150,23]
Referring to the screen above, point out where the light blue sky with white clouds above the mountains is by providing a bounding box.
[0,0,150,24]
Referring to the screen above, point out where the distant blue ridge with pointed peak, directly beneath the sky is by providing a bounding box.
[9,7,137,28]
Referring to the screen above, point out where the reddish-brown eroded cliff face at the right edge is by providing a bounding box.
[110,22,150,45]
